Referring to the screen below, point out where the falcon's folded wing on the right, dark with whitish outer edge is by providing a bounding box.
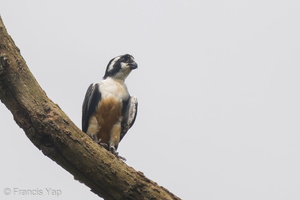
[120,97,138,141]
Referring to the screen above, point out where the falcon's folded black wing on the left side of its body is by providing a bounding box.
[82,83,101,133]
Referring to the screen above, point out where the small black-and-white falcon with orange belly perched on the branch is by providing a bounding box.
[82,54,138,158]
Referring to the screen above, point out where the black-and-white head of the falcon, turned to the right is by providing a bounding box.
[103,54,138,81]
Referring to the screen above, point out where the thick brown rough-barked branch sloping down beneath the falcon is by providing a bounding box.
[0,17,179,200]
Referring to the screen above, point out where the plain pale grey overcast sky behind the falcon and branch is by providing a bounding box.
[0,0,300,200]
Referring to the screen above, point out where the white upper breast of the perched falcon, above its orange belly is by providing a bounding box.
[99,78,129,101]
